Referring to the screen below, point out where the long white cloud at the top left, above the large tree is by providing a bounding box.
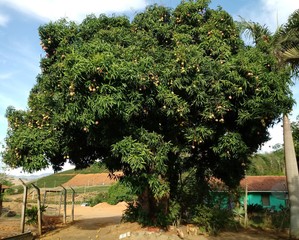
[0,0,146,21]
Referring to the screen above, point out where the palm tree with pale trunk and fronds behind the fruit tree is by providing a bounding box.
[240,10,299,239]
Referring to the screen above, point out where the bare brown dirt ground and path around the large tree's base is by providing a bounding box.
[0,203,288,240]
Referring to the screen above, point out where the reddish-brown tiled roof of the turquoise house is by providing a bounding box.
[240,176,287,192]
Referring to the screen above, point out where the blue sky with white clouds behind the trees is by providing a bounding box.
[0,0,299,175]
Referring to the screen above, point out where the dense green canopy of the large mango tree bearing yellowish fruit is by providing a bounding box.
[3,0,293,225]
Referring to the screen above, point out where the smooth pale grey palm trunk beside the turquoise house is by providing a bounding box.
[283,115,299,239]
